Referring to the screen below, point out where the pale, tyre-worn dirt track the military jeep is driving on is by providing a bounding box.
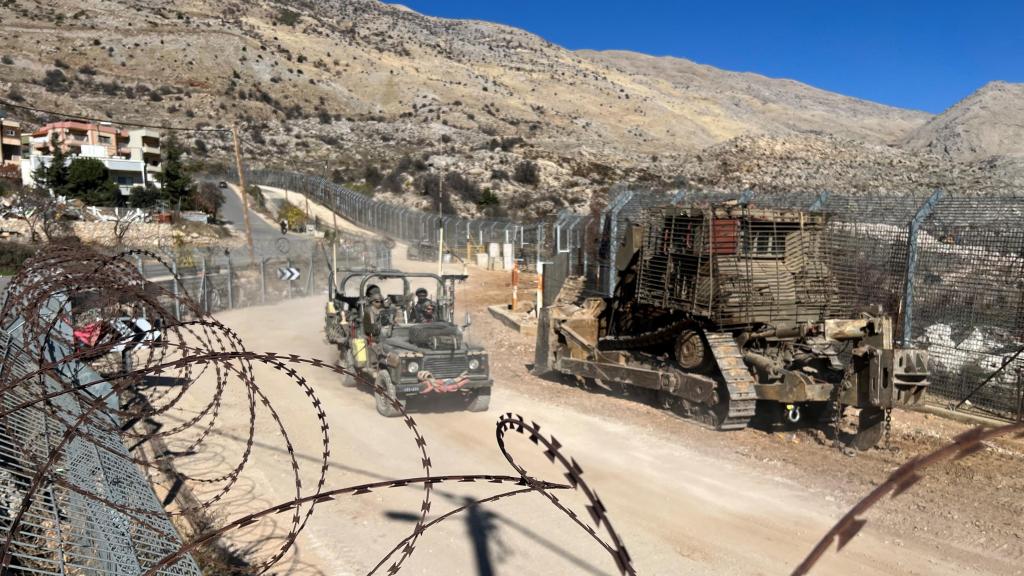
[157,280,1020,574]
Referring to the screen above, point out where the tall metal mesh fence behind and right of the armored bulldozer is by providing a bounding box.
[561,191,1024,419]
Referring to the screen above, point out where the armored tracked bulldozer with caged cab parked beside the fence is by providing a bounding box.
[536,204,928,449]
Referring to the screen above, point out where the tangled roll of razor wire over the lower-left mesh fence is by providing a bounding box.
[0,246,635,574]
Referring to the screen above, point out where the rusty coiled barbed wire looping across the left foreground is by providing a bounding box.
[0,246,635,574]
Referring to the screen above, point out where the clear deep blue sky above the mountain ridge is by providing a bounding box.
[401,0,1024,113]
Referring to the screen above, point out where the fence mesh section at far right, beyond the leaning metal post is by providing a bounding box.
[911,197,1024,416]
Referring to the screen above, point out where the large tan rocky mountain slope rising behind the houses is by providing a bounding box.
[0,0,1011,217]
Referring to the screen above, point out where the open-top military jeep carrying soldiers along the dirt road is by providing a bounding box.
[325,272,493,417]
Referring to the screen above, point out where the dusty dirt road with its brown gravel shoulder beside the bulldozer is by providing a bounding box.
[153,187,1024,575]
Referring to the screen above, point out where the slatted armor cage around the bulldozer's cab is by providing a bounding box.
[637,204,848,327]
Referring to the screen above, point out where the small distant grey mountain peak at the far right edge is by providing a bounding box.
[903,82,1024,161]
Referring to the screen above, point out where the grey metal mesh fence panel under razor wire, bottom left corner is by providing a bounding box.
[0,295,201,576]
